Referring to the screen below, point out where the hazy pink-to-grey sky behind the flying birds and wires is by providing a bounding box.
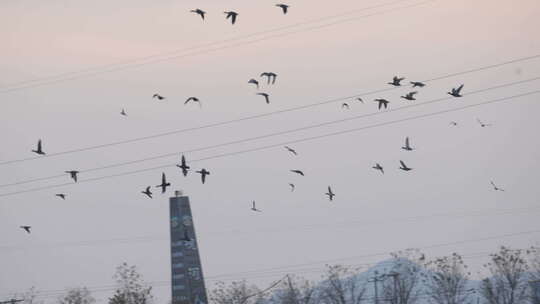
[0,0,540,303]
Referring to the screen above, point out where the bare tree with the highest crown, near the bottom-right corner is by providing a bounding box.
[480,246,528,304]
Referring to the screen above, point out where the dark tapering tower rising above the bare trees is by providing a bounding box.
[169,191,208,304]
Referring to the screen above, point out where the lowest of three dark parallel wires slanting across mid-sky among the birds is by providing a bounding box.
[0,90,540,197]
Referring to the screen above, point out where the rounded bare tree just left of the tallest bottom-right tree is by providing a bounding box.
[425,253,471,304]
